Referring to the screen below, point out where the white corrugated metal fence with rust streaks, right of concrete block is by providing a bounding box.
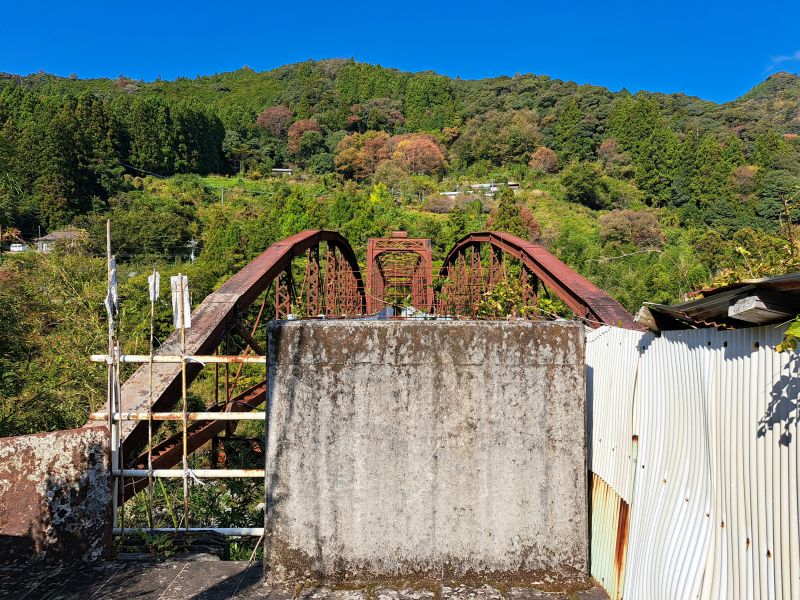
[586,327,800,600]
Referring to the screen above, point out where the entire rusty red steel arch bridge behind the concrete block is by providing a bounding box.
[111,230,640,499]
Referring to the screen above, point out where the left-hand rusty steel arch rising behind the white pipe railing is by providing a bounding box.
[116,230,366,463]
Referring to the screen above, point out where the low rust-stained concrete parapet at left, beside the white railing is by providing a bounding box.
[0,427,111,560]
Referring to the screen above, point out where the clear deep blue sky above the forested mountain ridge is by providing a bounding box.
[0,0,800,102]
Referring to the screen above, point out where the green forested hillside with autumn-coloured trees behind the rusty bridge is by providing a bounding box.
[0,60,800,434]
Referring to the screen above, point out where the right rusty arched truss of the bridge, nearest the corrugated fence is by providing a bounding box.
[436,231,641,330]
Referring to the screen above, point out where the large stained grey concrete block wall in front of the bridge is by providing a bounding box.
[265,321,588,587]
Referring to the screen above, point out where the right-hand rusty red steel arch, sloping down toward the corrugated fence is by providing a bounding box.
[437,231,641,330]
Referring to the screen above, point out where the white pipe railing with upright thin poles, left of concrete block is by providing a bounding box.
[98,222,268,538]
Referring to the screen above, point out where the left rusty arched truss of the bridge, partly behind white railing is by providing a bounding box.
[121,230,366,498]
